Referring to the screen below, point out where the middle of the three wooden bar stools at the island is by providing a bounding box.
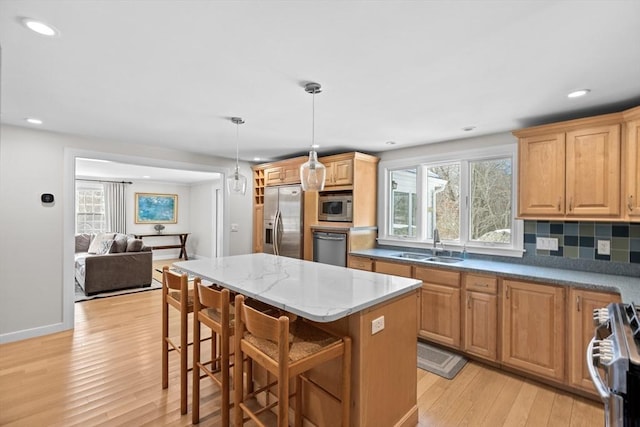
[191,277,235,427]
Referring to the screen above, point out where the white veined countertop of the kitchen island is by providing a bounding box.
[174,253,422,322]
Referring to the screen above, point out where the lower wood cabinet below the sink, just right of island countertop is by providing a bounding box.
[415,267,460,349]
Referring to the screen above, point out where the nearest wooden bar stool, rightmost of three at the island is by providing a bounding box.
[233,295,351,427]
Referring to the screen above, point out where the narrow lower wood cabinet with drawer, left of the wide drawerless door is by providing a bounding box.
[462,274,498,362]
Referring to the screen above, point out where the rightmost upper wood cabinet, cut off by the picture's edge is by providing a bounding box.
[622,107,640,221]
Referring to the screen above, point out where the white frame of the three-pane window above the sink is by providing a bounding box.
[378,144,524,257]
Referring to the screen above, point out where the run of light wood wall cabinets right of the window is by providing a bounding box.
[514,108,640,221]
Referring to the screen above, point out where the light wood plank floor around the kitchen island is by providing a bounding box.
[0,284,603,427]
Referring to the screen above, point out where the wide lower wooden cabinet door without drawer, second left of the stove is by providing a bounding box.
[502,280,565,381]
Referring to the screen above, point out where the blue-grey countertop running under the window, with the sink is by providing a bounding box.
[350,248,640,304]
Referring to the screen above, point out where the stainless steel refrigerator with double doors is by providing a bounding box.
[264,185,303,258]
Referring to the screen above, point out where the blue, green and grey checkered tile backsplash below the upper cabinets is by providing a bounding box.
[524,221,640,264]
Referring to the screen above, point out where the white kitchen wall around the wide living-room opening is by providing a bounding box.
[0,125,252,342]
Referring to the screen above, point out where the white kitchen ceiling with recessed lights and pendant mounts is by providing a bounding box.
[0,0,640,165]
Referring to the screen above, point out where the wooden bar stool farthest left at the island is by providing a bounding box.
[162,265,193,414]
